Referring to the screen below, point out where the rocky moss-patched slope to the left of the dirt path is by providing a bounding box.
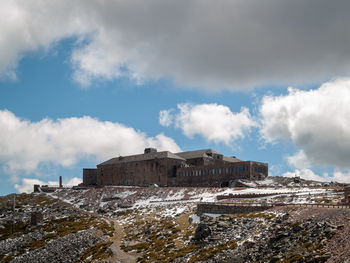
[0,194,114,263]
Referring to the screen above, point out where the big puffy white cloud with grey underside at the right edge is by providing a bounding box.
[260,79,350,169]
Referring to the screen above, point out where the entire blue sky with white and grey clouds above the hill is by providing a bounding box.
[0,0,350,194]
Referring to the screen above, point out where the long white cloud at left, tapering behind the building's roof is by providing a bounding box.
[0,110,181,180]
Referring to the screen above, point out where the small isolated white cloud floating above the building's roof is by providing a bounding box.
[159,103,256,145]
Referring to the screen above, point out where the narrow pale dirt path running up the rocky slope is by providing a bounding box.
[110,220,138,263]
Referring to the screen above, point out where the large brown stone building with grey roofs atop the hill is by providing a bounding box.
[83,148,268,187]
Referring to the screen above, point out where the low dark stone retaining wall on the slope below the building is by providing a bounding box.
[197,203,271,216]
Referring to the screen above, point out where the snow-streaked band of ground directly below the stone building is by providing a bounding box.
[48,179,339,220]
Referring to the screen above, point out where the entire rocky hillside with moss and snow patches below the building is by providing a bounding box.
[0,182,350,262]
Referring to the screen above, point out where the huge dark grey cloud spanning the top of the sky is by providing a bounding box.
[0,0,350,90]
